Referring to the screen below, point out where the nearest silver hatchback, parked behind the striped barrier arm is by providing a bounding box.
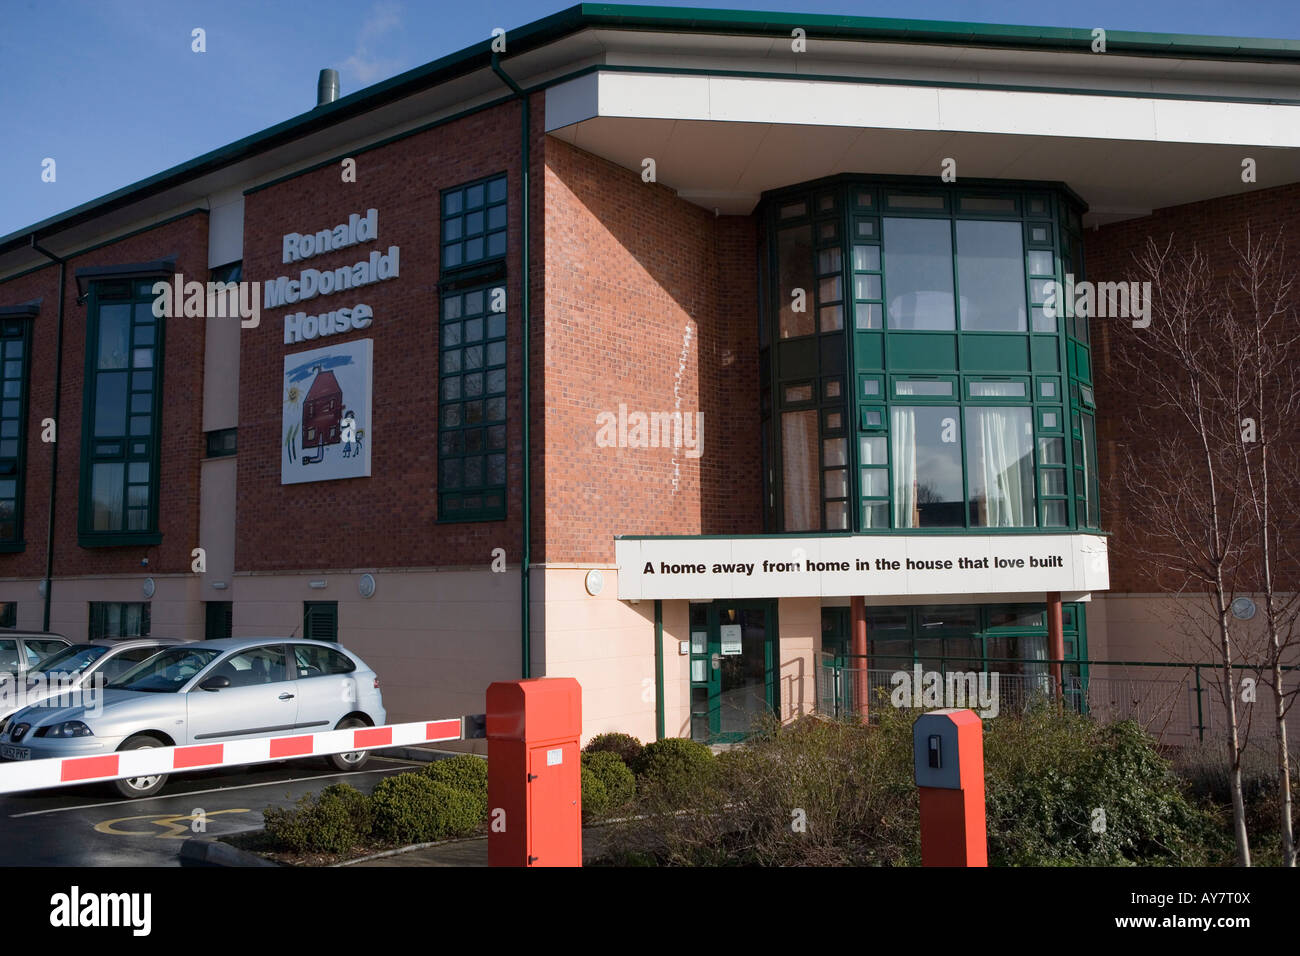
[0,637,386,797]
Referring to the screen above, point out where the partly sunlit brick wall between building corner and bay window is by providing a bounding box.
[534,138,762,562]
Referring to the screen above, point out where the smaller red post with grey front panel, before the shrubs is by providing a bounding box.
[911,710,988,866]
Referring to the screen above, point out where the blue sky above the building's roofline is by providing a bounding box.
[0,0,1300,235]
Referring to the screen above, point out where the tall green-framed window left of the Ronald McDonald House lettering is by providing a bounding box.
[78,278,165,548]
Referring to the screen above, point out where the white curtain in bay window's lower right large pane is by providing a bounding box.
[966,408,1035,528]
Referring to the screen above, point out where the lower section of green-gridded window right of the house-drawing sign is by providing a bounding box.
[438,282,508,522]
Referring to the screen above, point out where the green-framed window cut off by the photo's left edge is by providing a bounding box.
[0,319,31,553]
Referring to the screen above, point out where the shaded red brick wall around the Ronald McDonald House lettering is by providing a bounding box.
[235,98,542,571]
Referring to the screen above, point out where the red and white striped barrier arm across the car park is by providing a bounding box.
[0,717,465,793]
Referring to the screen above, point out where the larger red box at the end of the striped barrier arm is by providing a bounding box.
[488,678,582,866]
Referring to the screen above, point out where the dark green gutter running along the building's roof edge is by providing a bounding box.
[0,4,1300,255]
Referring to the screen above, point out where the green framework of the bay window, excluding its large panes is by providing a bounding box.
[759,176,1099,533]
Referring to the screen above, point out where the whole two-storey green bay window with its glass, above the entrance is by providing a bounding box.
[759,176,1100,532]
